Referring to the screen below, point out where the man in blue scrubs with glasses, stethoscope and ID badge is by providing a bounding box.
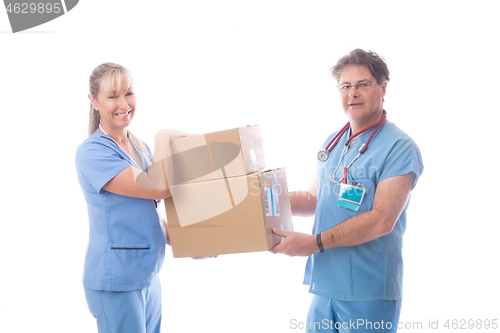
[273,49,423,332]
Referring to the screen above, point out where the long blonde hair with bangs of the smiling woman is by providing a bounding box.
[89,62,151,158]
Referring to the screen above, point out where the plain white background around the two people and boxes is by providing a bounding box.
[0,0,500,333]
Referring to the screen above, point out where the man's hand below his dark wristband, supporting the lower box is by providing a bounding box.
[271,228,318,256]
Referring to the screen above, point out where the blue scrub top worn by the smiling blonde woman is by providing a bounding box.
[76,130,166,291]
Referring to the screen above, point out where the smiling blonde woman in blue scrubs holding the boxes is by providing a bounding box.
[76,63,180,333]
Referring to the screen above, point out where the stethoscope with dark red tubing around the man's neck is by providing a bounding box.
[318,110,387,183]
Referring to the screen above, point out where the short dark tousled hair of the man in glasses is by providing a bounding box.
[330,49,389,84]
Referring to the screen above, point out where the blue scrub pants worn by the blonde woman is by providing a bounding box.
[84,278,162,333]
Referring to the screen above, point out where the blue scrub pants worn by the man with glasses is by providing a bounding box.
[306,295,401,333]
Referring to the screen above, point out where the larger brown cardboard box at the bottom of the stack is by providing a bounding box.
[165,169,293,258]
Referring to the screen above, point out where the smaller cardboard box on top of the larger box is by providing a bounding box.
[171,125,266,185]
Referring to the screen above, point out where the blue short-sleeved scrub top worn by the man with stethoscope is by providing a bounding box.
[304,123,424,301]
